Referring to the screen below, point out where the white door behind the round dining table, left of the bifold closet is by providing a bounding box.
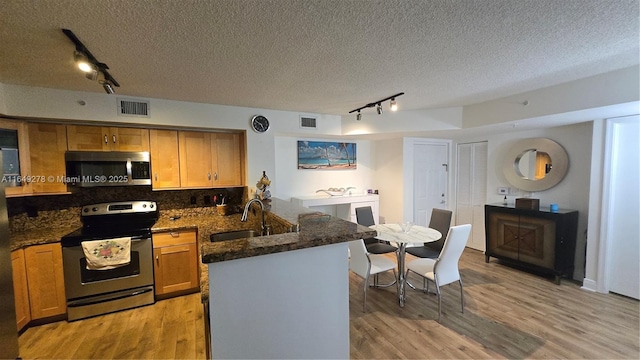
[413,143,449,226]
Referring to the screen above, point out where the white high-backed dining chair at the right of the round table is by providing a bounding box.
[406,224,471,322]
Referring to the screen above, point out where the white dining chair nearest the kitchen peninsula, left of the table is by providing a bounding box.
[349,239,397,312]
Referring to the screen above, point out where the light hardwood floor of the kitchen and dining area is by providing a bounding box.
[20,249,640,359]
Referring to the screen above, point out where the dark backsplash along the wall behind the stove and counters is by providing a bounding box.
[7,186,246,232]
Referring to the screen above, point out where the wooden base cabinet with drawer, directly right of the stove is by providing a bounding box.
[153,230,200,297]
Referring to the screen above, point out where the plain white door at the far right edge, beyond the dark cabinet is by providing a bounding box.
[606,116,640,299]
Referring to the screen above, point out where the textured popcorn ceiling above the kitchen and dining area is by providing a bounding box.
[0,0,639,114]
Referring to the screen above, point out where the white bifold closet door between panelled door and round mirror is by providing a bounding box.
[455,142,487,251]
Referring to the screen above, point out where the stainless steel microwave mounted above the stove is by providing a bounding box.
[65,151,151,187]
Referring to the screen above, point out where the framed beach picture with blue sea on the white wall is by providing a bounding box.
[298,140,358,170]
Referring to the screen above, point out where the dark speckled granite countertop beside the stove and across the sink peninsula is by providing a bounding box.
[10,199,377,303]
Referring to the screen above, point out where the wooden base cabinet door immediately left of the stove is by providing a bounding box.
[24,243,67,320]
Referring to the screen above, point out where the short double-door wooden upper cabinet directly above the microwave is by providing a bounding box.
[67,125,149,151]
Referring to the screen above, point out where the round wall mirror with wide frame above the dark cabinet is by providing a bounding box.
[502,138,569,191]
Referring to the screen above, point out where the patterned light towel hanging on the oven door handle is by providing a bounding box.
[82,237,131,270]
